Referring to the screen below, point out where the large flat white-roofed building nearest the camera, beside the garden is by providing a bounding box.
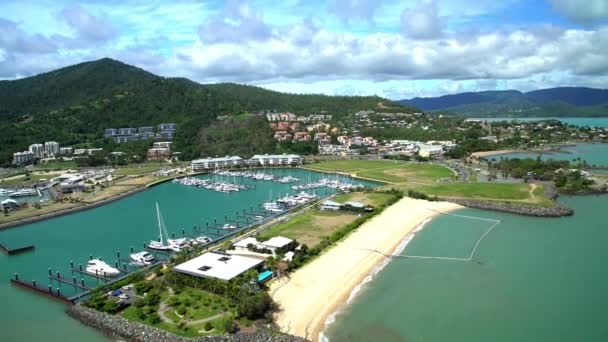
[173,252,264,281]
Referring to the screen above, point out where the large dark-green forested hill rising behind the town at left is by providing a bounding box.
[0,58,417,165]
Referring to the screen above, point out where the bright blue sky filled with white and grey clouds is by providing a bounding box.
[0,0,608,100]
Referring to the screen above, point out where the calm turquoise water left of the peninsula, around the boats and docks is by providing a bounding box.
[0,169,372,342]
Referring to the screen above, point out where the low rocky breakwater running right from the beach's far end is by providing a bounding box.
[443,198,574,217]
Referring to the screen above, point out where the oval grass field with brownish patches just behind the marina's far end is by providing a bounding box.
[307,160,454,183]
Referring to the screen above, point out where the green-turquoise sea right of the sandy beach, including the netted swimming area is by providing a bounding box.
[327,196,608,342]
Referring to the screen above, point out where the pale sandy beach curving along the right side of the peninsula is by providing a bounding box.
[270,198,462,341]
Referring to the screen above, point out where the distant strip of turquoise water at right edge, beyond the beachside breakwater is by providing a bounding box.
[487,144,608,166]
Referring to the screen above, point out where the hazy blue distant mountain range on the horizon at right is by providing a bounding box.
[397,87,608,117]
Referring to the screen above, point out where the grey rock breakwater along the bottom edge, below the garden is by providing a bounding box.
[68,305,307,342]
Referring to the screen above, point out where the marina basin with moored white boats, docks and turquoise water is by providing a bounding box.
[0,169,375,341]
